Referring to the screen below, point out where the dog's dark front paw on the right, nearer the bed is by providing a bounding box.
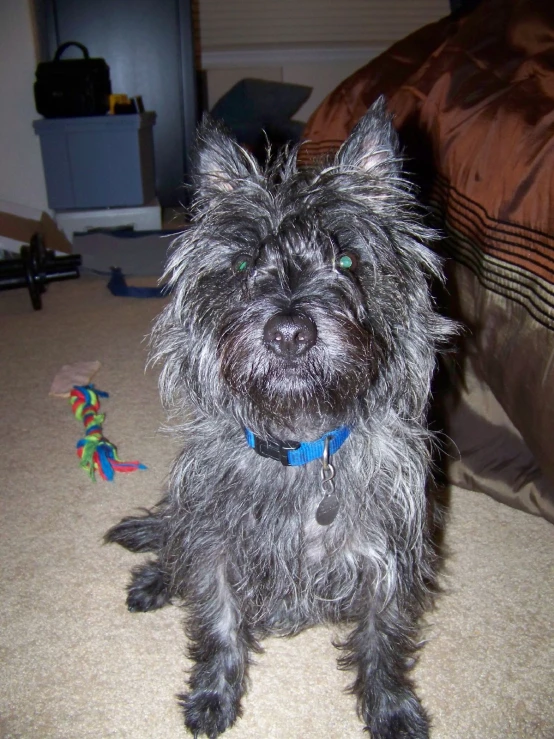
[365,691,429,739]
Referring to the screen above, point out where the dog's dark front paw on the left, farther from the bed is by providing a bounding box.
[179,690,239,739]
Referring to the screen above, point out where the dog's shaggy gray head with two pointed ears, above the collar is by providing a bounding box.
[155,101,444,433]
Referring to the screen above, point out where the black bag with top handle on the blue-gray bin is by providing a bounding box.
[35,41,112,118]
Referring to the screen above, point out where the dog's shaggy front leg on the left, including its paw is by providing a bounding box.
[180,565,254,739]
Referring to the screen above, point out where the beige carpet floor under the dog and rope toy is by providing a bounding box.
[0,279,554,739]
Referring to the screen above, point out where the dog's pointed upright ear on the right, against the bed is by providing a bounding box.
[336,95,400,176]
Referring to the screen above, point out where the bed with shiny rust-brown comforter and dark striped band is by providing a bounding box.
[301,0,554,522]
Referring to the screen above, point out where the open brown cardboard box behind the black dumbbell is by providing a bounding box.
[0,201,72,254]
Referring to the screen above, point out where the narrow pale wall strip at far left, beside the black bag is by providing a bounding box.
[0,0,47,211]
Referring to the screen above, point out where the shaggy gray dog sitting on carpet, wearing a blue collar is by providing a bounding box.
[106,100,449,739]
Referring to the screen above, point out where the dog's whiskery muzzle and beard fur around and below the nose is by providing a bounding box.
[218,306,377,434]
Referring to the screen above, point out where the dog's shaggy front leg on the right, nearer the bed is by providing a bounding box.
[339,601,429,739]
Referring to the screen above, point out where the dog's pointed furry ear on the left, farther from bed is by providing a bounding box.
[192,115,261,199]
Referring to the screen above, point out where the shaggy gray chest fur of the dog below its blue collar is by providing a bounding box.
[167,422,418,631]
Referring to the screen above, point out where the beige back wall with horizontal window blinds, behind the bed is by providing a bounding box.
[198,0,449,121]
